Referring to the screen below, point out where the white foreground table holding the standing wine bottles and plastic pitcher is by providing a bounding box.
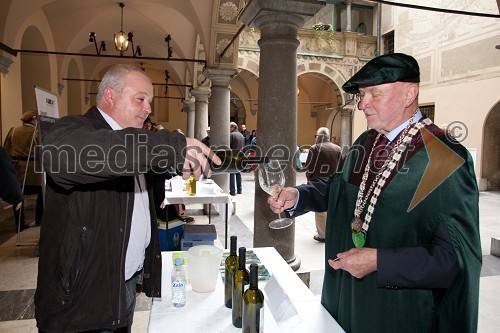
[148,247,344,333]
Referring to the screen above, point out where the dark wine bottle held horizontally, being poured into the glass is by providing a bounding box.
[210,149,269,174]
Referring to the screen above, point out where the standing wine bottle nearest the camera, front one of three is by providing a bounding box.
[242,264,264,333]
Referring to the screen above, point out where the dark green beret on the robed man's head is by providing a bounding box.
[342,53,420,94]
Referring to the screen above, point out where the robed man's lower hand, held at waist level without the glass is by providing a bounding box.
[328,247,377,279]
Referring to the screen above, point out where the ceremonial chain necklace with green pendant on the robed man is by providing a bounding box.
[351,109,432,248]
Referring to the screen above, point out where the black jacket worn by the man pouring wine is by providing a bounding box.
[35,108,186,332]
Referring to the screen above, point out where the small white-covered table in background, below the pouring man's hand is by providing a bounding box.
[162,181,233,249]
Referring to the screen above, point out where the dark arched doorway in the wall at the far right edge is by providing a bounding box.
[481,101,500,191]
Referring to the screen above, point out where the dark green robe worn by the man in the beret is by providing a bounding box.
[322,125,482,333]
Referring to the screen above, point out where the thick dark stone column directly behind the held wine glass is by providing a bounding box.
[240,0,324,270]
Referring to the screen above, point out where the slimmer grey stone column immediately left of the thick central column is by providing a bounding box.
[204,68,240,193]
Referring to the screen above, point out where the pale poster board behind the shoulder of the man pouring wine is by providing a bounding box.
[35,86,59,144]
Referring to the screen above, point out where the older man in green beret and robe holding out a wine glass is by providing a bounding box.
[268,53,482,333]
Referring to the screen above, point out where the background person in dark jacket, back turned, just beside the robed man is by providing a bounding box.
[305,127,342,242]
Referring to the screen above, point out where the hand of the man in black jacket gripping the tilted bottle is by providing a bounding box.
[182,137,222,179]
